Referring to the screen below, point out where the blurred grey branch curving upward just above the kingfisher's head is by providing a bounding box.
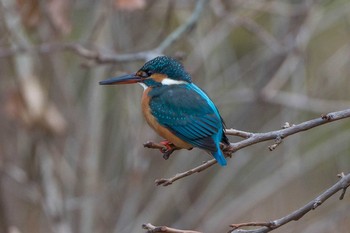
[0,0,209,64]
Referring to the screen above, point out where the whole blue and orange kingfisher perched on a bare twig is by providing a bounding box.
[99,56,229,166]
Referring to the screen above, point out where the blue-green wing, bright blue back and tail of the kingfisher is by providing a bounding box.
[149,83,227,164]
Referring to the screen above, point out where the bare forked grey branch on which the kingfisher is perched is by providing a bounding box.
[151,109,350,186]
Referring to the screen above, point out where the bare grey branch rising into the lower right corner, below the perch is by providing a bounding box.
[230,173,350,233]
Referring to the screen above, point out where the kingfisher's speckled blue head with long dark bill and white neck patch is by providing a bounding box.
[100,56,191,88]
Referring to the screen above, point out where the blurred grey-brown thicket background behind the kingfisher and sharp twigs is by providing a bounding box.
[0,0,350,233]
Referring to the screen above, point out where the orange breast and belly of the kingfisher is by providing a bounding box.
[141,87,193,149]
